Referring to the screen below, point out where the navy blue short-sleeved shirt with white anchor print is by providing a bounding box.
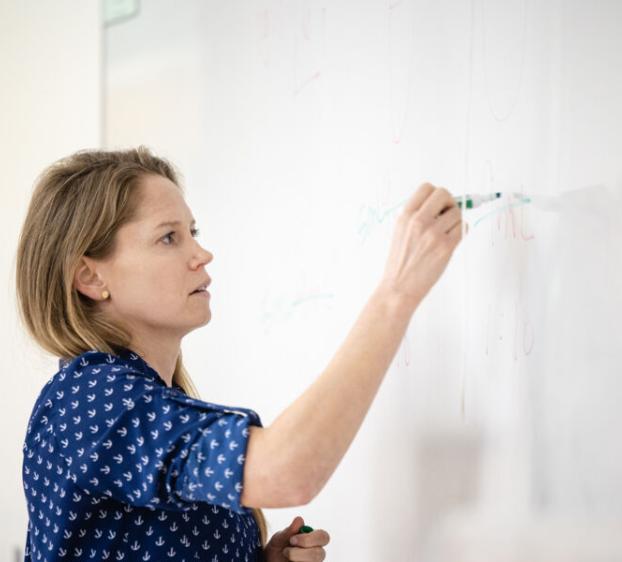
[22,348,263,562]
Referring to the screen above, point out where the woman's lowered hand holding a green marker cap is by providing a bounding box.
[264,516,330,562]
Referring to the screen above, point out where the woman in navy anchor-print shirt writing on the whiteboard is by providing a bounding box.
[16,147,462,562]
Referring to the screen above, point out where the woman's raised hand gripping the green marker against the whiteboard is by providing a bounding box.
[381,183,468,310]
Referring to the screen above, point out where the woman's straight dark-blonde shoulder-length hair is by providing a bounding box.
[16,145,267,547]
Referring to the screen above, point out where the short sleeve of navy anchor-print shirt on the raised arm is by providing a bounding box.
[55,371,262,513]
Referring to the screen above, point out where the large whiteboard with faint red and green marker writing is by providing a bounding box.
[104,0,622,562]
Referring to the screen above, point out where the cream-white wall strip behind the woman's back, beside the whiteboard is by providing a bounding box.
[0,0,102,561]
